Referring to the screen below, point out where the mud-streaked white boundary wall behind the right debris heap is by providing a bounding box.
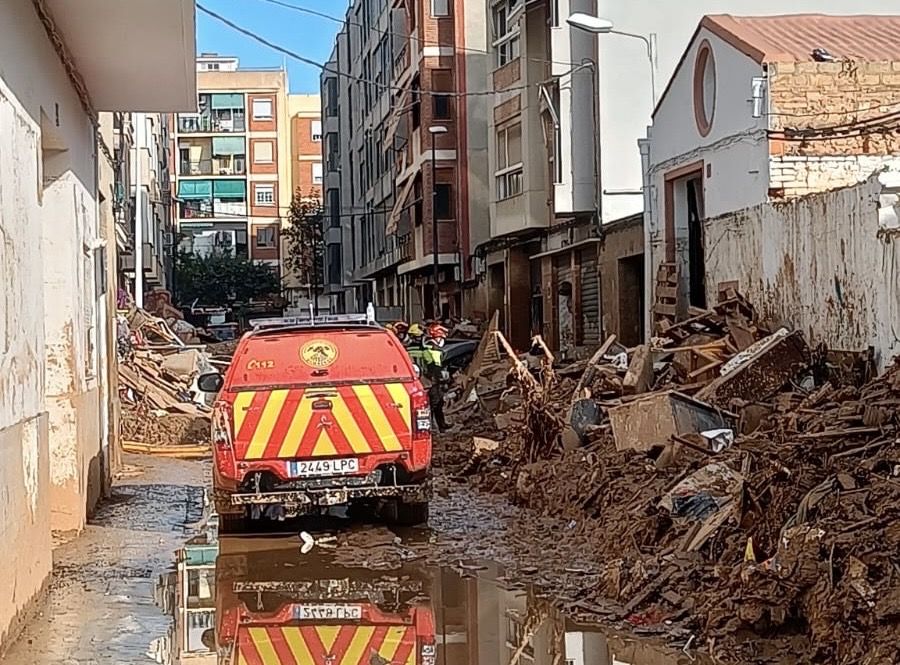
[704,171,900,367]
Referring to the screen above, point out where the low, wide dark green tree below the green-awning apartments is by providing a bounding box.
[175,252,281,307]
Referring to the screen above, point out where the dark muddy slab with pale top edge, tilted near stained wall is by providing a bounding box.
[697,331,810,406]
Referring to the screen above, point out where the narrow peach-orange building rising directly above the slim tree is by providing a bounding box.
[288,95,324,201]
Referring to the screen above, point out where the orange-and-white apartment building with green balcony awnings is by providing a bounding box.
[172,53,293,278]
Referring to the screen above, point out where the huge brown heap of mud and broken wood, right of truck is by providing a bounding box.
[444,292,900,663]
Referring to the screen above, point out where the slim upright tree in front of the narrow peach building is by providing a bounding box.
[281,188,325,311]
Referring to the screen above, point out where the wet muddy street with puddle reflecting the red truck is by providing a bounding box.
[0,448,697,665]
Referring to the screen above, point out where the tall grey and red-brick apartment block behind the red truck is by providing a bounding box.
[322,0,489,319]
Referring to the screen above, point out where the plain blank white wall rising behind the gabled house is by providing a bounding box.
[597,0,900,221]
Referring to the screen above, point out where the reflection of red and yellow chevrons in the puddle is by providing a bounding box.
[237,625,416,665]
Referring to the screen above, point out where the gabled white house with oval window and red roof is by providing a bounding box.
[641,14,900,339]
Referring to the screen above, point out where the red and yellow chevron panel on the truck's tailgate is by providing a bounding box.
[233,383,412,460]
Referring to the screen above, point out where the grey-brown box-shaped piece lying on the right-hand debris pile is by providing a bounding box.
[609,390,736,452]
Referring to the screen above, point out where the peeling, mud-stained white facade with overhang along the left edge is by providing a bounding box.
[0,0,196,648]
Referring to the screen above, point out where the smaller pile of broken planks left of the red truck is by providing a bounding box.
[118,307,215,450]
